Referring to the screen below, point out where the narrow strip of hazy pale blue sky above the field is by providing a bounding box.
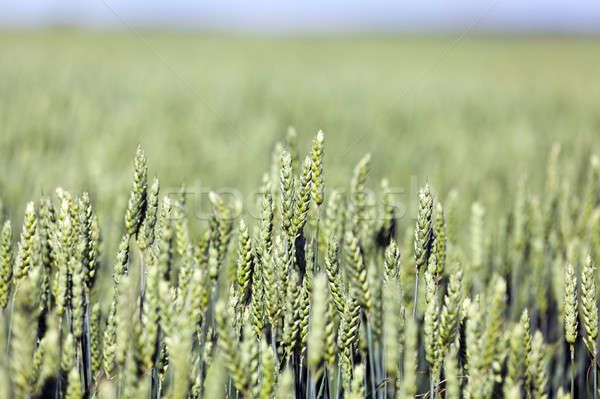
[0,0,600,33]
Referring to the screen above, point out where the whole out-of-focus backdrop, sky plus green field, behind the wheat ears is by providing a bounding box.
[0,0,600,247]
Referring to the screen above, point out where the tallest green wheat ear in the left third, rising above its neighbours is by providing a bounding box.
[125,145,148,236]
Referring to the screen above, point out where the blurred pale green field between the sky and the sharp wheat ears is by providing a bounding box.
[0,30,600,223]
